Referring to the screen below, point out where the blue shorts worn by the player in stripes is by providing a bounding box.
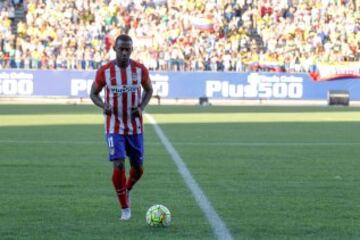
[105,134,144,166]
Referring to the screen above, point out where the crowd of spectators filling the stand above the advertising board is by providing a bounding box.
[0,0,360,72]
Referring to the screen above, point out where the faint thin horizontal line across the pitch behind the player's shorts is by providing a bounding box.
[0,139,360,147]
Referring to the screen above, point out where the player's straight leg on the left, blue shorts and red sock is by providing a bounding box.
[106,134,129,220]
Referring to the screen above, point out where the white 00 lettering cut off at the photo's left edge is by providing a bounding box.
[0,79,34,96]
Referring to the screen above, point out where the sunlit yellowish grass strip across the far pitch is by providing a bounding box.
[0,112,360,127]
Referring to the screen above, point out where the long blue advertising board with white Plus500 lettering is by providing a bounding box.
[0,69,360,100]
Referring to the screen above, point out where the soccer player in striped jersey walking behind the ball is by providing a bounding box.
[90,34,153,221]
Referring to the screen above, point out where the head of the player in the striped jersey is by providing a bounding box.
[114,34,133,64]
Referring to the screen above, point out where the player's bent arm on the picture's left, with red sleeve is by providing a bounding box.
[90,69,112,115]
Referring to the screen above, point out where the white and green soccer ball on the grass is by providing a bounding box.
[145,204,171,227]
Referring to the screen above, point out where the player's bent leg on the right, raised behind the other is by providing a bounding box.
[125,134,144,191]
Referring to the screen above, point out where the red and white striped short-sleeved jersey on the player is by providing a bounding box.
[95,60,150,135]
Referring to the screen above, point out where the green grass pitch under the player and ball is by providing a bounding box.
[0,105,360,240]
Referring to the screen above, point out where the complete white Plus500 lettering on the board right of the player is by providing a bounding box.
[206,73,303,99]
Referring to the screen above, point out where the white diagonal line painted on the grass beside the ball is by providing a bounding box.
[145,114,233,240]
